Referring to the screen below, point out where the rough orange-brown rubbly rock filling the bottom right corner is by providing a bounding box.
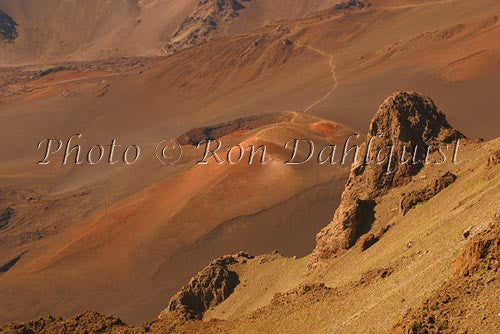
[390,214,500,334]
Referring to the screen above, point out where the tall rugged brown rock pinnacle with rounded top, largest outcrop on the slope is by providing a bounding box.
[309,92,463,269]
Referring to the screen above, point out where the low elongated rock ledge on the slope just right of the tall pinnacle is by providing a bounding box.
[399,172,457,216]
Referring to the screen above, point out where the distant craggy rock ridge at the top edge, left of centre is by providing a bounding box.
[165,0,251,54]
